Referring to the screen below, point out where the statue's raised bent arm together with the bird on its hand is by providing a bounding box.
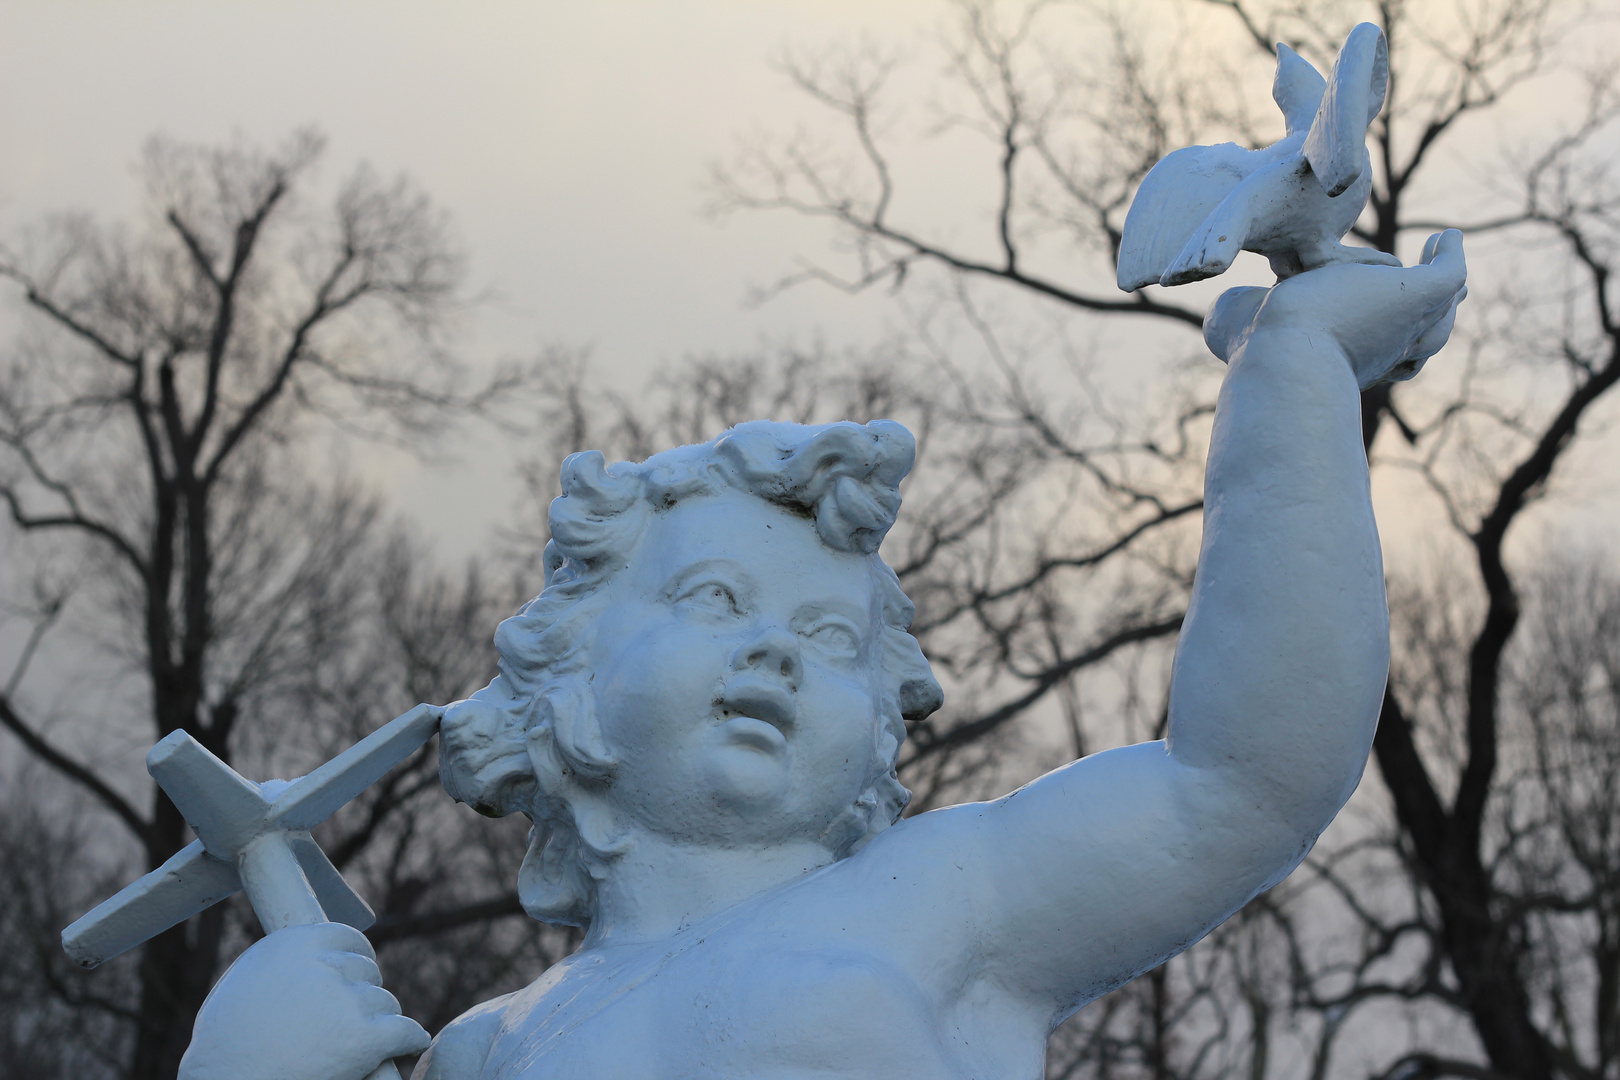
[861,26,1466,1023]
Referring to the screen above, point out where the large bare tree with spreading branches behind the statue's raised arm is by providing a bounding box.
[716,0,1620,1080]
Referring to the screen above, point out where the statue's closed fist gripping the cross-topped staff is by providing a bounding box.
[180,923,429,1080]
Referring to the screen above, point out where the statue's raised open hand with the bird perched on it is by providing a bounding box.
[1204,228,1468,390]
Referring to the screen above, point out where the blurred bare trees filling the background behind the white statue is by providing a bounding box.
[0,0,1620,1080]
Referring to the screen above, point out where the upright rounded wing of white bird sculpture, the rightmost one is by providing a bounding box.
[1304,23,1390,198]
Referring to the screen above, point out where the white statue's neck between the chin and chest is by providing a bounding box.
[585,832,833,949]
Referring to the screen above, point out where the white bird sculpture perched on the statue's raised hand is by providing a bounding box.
[1119,23,1400,293]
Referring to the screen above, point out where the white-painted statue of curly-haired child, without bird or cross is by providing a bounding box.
[181,233,1464,1080]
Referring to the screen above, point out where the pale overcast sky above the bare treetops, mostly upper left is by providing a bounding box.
[0,0,1620,554]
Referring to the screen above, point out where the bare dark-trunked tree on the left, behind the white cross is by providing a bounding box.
[0,133,537,1080]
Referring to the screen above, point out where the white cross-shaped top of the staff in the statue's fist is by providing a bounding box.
[62,704,444,1080]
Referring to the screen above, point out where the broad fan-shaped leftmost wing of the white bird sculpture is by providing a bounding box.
[1118,142,1265,293]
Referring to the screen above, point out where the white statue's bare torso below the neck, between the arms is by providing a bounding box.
[455,868,1047,1080]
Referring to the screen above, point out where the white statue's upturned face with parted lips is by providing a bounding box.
[591,492,881,844]
